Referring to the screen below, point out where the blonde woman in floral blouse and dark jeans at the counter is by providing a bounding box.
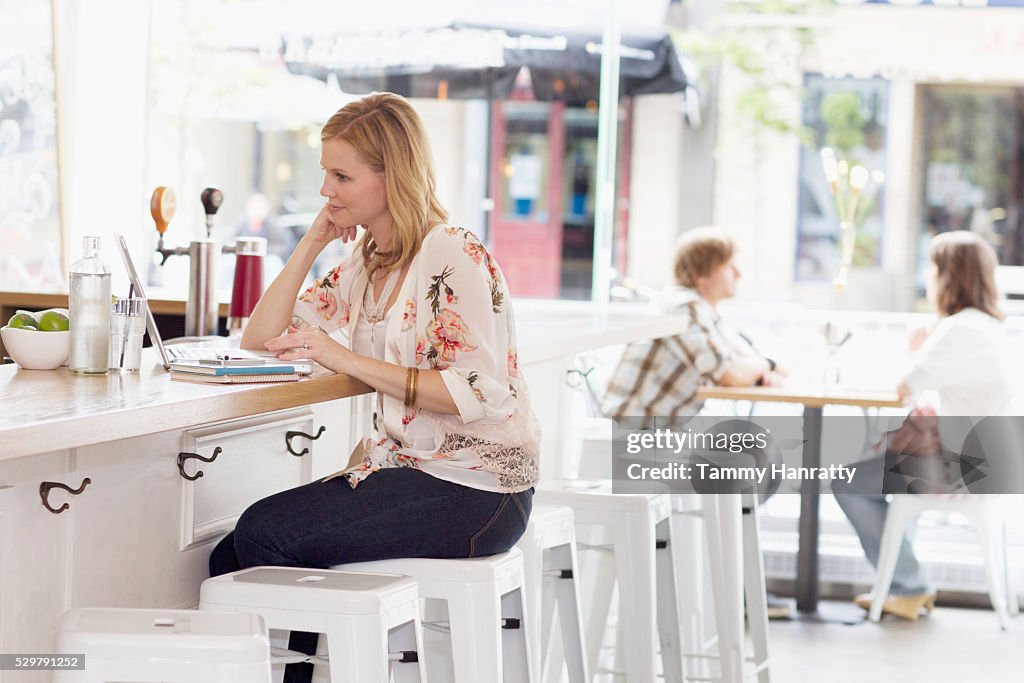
[210,93,540,680]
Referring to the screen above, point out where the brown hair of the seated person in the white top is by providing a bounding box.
[928,230,1005,321]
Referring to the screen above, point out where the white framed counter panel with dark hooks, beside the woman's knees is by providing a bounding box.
[181,408,314,550]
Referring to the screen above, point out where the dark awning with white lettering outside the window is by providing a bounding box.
[282,22,696,103]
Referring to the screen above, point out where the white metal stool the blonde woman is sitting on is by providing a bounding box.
[335,548,532,683]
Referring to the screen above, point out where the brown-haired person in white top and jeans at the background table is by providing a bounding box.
[833,230,1014,621]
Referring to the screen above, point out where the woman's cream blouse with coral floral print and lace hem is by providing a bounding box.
[293,225,540,493]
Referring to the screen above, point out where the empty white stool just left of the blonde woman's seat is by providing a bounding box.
[200,567,426,683]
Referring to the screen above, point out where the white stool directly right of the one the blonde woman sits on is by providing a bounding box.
[516,505,590,683]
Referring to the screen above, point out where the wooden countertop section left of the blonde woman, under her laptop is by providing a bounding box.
[0,348,372,461]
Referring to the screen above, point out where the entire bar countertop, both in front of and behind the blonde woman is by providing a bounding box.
[0,300,681,461]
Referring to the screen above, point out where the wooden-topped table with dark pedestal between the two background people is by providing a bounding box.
[697,384,903,614]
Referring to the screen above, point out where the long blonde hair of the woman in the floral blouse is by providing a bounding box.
[321,92,447,276]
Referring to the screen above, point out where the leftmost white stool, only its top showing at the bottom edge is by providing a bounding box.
[53,608,270,683]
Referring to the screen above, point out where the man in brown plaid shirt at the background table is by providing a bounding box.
[601,226,784,418]
